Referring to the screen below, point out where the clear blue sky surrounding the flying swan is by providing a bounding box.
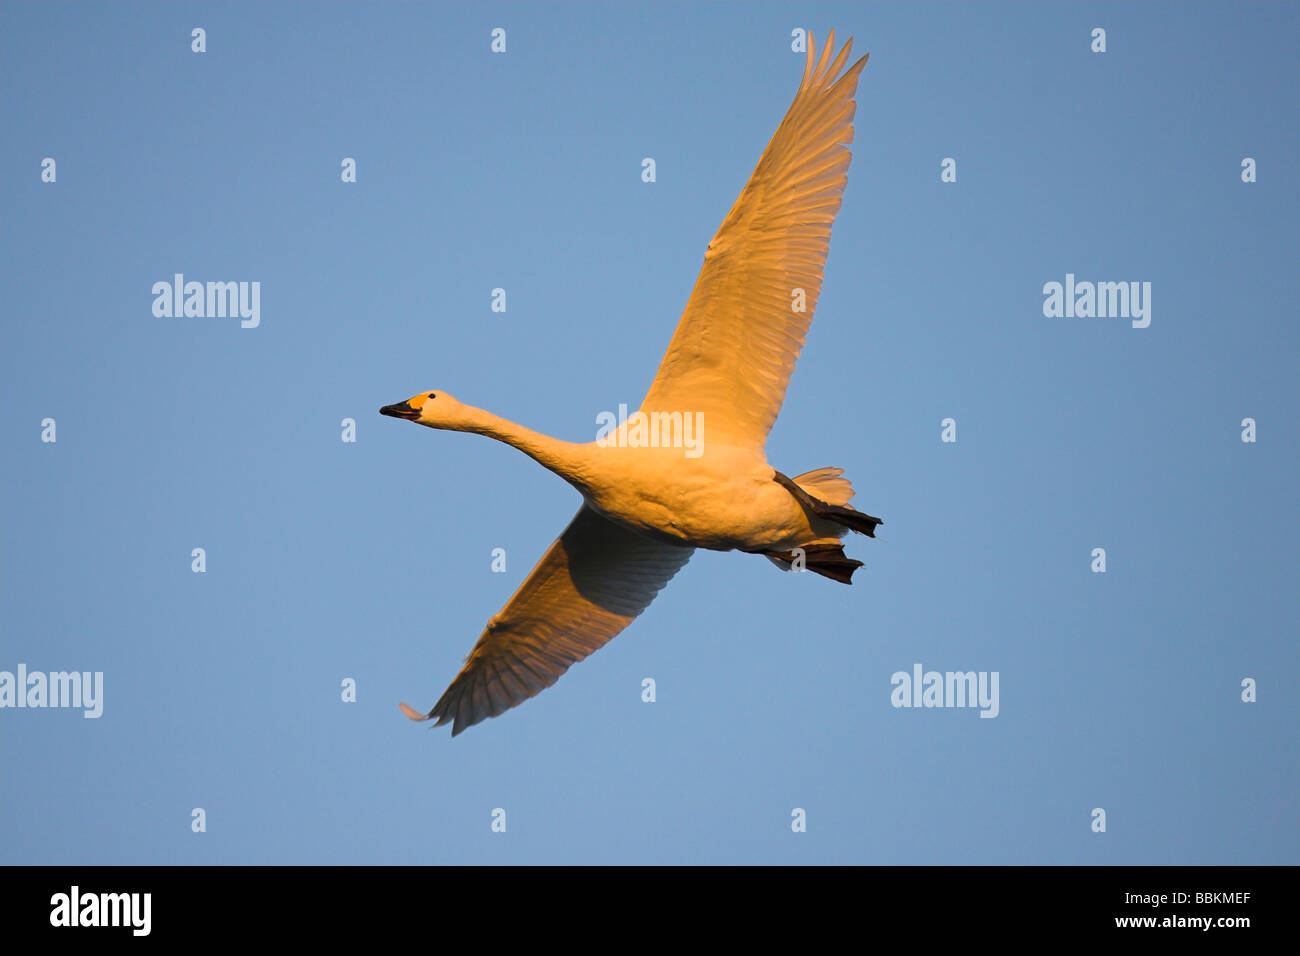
[0,3,1300,864]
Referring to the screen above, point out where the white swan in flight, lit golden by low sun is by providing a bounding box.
[380,30,883,736]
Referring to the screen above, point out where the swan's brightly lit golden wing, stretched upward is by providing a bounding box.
[641,30,867,447]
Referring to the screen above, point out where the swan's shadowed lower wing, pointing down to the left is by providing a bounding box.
[402,505,694,736]
